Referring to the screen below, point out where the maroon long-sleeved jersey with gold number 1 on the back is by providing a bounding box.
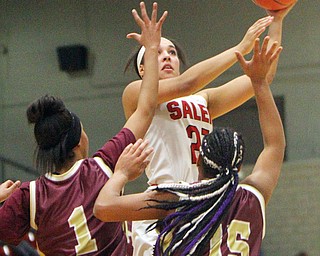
[0,129,135,256]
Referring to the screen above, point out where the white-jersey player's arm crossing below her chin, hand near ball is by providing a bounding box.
[122,16,273,118]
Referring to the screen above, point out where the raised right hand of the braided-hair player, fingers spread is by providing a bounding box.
[236,36,282,85]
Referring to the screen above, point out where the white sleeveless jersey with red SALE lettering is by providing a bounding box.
[145,95,212,185]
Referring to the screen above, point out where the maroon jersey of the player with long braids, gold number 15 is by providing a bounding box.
[205,184,265,256]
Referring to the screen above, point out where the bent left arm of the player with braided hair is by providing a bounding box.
[93,139,175,222]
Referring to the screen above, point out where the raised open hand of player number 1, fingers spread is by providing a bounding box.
[127,2,168,47]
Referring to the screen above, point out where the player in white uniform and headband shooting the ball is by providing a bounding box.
[122,2,293,256]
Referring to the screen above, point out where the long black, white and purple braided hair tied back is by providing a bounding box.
[149,127,244,256]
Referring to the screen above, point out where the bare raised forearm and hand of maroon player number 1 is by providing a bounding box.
[124,2,167,139]
